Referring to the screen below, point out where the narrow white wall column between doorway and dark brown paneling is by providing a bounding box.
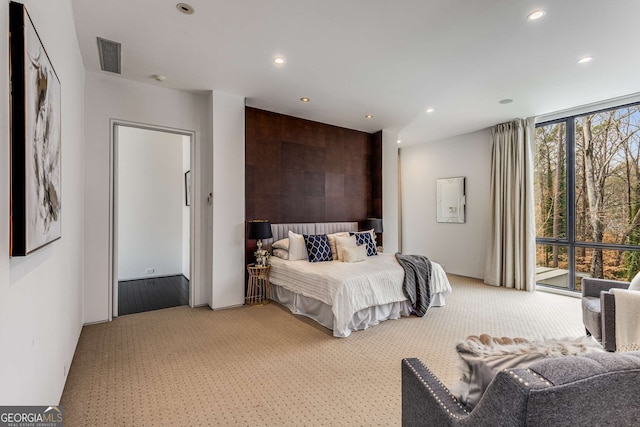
[209,92,245,309]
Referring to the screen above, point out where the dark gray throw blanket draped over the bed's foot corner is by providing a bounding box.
[396,252,431,317]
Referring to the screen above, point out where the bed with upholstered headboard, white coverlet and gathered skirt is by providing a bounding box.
[265,222,451,337]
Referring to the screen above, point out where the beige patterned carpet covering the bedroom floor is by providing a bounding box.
[61,276,584,426]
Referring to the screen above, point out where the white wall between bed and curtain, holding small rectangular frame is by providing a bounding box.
[402,129,491,279]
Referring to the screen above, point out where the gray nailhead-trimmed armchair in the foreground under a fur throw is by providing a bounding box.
[402,352,640,427]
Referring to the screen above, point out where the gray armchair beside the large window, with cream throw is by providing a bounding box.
[582,277,629,351]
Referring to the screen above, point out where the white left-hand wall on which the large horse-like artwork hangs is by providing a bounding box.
[0,0,85,405]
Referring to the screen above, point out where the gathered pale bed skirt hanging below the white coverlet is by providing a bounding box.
[271,283,411,338]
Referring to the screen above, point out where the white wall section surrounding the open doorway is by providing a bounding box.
[84,72,211,323]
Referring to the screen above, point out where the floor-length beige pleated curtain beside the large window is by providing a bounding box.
[484,119,536,291]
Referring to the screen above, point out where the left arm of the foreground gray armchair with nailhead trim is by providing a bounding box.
[402,359,469,427]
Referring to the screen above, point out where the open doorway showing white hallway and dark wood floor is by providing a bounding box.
[110,122,195,317]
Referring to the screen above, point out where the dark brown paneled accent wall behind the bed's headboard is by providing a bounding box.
[245,107,382,223]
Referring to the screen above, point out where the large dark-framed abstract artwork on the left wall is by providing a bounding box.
[9,2,62,256]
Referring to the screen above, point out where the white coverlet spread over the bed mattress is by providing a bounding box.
[270,253,451,333]
